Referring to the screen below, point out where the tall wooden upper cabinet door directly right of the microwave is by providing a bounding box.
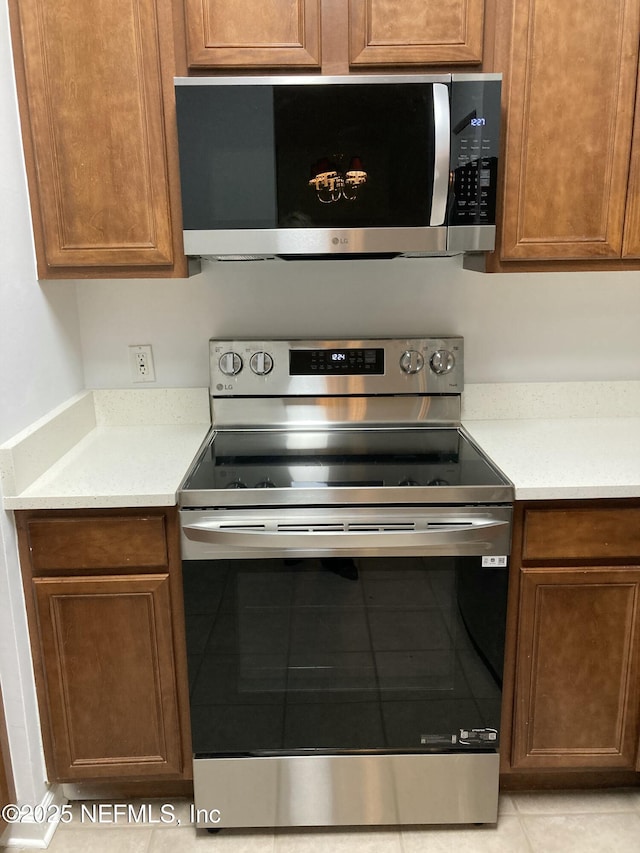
[496,0,640,260]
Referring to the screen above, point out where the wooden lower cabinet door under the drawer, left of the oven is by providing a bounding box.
[33,574,182,781]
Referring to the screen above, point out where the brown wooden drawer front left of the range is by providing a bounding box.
[27,516,168,573]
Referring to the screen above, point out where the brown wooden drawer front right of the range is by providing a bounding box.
[522,507,640,560]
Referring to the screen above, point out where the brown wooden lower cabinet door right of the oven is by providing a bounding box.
[512,568,640,770]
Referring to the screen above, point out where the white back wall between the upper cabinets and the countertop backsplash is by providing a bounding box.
[78,258,640,387]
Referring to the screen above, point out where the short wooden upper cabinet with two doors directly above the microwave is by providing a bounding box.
[184,0,485,74]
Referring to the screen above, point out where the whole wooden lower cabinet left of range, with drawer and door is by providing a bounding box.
[17,510,190,782]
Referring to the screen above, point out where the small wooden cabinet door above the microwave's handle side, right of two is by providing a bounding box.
[349,0,484,66]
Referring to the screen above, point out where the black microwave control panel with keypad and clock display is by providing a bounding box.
[449,74,501,225]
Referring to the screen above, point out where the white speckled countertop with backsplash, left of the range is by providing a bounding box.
[0,388,210,509]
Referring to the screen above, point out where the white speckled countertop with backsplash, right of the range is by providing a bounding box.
[462,381,640,500]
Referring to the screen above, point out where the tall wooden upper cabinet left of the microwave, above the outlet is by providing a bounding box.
[11,0,186,278]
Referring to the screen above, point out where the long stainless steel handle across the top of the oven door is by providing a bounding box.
[182,517,509,551]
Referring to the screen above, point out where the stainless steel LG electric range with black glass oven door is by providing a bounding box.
[180,337,513,828]
